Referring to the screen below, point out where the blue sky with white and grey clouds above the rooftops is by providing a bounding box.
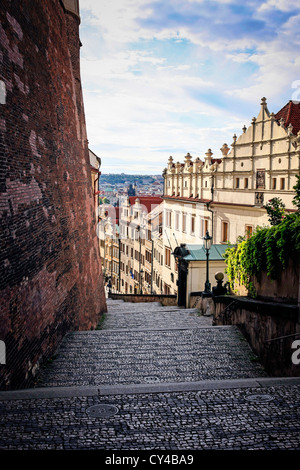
[80,0,300,174]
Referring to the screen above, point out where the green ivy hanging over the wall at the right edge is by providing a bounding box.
[225,210,300,296]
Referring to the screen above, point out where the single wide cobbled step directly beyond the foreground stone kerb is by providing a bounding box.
[35,327,265,387]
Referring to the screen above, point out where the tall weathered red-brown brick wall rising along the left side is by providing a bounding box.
[0,0,106,389]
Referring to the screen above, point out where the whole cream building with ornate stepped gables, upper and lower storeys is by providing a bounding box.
[163,98,300,298]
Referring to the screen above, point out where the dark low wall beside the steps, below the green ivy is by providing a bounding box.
[213,296,300,377]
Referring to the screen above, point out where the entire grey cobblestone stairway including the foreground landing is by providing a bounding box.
[0,301,300,452]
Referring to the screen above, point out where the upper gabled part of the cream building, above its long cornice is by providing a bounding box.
[164,98,300,209]
